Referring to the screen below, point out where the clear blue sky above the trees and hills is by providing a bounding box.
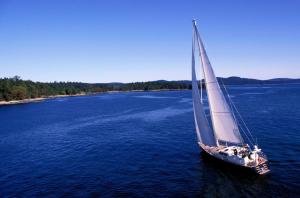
[0,0,300,82]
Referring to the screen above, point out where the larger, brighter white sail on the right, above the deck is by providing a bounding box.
[194,23,243,144]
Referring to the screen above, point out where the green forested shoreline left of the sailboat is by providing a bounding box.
[0,76,191,101]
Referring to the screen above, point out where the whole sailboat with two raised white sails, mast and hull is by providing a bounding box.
[192,20,270,175]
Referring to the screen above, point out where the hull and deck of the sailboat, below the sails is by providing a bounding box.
[199,143,270,175]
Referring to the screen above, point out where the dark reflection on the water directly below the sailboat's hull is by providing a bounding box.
[200,152,271,197]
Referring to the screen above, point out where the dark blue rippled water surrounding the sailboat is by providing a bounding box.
[0,85,300,197]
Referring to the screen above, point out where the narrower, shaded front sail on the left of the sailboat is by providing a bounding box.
[192,27,216,146]
